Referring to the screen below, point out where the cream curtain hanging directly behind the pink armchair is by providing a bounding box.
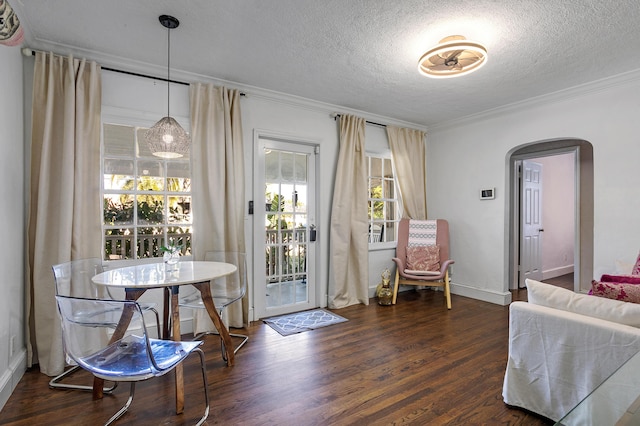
[387,126,427,220]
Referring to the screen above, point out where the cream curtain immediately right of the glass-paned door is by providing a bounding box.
[329,115,369,309]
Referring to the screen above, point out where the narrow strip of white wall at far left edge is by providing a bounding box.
[0,46,26,409]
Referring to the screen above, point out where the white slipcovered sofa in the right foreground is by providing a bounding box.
[502,280,640,421]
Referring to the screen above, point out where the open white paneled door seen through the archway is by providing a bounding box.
[518,160,544,288]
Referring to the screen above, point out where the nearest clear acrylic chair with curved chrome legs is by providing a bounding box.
[56,295,209,425]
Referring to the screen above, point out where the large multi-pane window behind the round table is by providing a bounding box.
[102,123,193,260]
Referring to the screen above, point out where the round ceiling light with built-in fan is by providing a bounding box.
[418,35,487,78]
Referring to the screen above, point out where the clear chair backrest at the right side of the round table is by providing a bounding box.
[204,251,247,308]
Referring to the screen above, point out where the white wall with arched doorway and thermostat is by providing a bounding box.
[427,74,640,303]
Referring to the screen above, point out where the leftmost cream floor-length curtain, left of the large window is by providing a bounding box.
[26,52,102,376]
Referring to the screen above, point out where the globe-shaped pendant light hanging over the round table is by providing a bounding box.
[144,15,190,158]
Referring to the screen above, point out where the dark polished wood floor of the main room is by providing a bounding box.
[0,280,564,426]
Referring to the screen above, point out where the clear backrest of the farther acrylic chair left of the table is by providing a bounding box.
[52,258,105,299]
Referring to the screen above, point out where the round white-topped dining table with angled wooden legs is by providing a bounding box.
[92,261,237,414]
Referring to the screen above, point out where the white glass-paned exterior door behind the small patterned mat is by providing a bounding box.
[253,136,318,319]
